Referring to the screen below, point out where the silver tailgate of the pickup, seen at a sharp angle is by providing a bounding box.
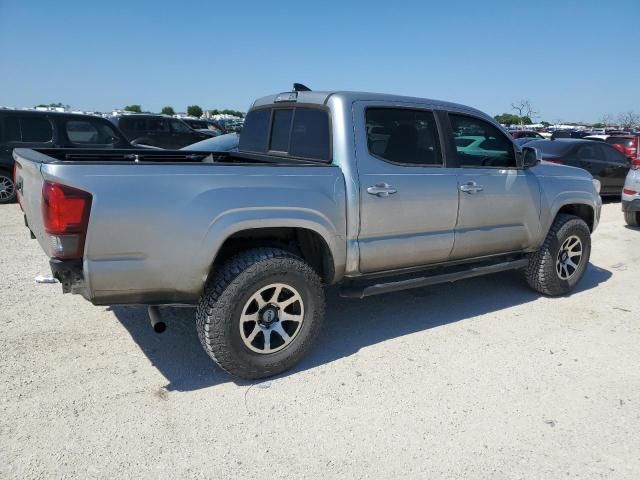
[13,148,51,256]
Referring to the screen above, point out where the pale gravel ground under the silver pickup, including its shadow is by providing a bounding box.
[0,203,640,480]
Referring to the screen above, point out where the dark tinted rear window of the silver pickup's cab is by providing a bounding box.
[239,106,331,163]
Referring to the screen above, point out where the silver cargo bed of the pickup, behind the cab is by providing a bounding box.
[14,149,346,305]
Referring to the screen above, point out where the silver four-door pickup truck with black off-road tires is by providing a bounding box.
[14,87,601,378]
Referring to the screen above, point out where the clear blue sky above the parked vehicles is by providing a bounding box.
[0,0,640,121]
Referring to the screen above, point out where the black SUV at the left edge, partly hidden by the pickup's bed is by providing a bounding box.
[0,110,133,203]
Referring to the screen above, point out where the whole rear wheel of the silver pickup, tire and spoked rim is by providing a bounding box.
[196,248,324,379]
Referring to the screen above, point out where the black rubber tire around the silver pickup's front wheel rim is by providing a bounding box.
[525,214,591,296]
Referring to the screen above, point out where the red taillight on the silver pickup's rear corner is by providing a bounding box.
[42,182,92,258]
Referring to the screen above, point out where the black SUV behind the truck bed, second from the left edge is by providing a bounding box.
[110,114,214,149]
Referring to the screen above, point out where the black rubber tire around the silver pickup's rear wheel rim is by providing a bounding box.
[196,248,324,379]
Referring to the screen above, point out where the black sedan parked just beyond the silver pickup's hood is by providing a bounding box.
[527,138,631,196]
